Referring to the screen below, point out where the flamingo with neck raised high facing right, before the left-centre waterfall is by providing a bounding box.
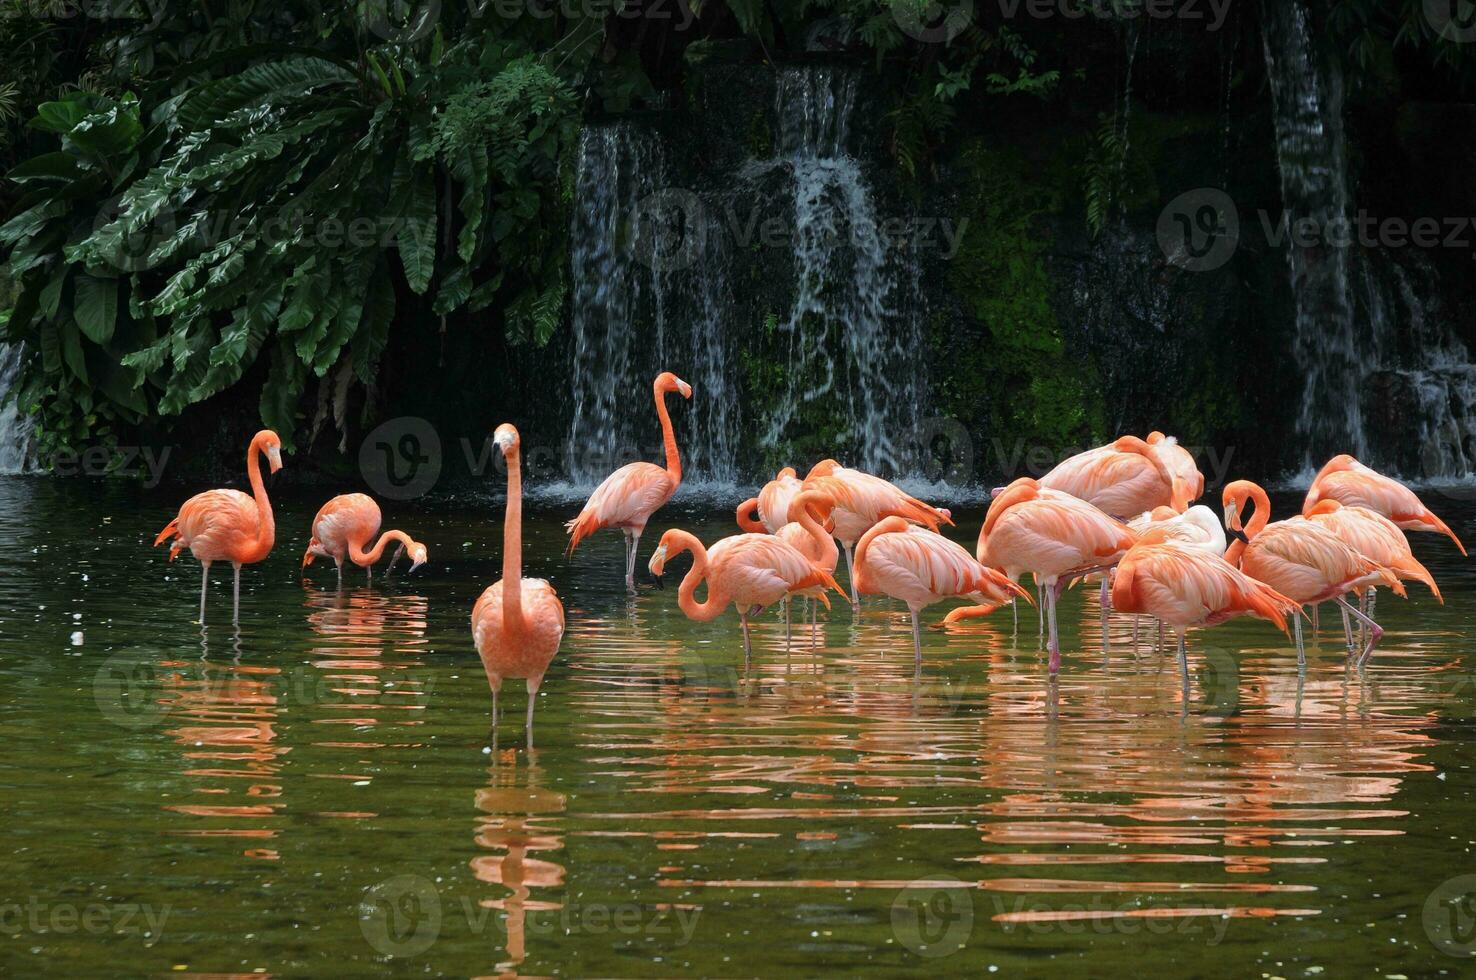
[565,370,692,593]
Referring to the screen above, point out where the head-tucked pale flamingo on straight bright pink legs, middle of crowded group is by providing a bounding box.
[949,477,1137,674]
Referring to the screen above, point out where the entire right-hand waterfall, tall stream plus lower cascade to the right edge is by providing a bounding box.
[1262,0,1476,481]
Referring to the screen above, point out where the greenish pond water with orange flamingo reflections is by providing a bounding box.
[0,480,1476,977]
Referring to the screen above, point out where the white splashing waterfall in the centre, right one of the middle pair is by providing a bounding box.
[760,68,924,475]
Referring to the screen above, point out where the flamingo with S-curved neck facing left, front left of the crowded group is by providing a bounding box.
[648,528,846,661]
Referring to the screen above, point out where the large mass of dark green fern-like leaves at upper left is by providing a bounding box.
[0,9,579,449]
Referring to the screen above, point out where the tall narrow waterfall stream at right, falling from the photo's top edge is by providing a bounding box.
[1262,0,1368,468]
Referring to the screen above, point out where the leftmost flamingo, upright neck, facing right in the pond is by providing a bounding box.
[154,429,282,624]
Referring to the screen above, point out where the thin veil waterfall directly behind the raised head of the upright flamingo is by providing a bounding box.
[567,123,739,486]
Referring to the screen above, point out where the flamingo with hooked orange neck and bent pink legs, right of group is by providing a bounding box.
[1222,480,1405,667]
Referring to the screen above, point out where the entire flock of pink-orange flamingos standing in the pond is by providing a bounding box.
[155,372,1466,729]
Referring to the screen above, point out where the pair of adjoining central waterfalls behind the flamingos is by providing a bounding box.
[565,68,924,489]
